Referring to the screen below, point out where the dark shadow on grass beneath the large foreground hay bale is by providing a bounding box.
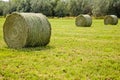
[6,45,55,52]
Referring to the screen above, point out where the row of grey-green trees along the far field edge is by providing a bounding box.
[0,0,120,17]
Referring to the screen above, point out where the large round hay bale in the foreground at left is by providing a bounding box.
[3,13,51,48]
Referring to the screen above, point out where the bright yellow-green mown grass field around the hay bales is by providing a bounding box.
[0,18,120,80]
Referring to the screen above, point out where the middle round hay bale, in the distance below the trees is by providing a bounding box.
[75,15,92,27]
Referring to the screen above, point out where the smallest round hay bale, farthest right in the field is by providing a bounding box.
[104,15,118,25]
